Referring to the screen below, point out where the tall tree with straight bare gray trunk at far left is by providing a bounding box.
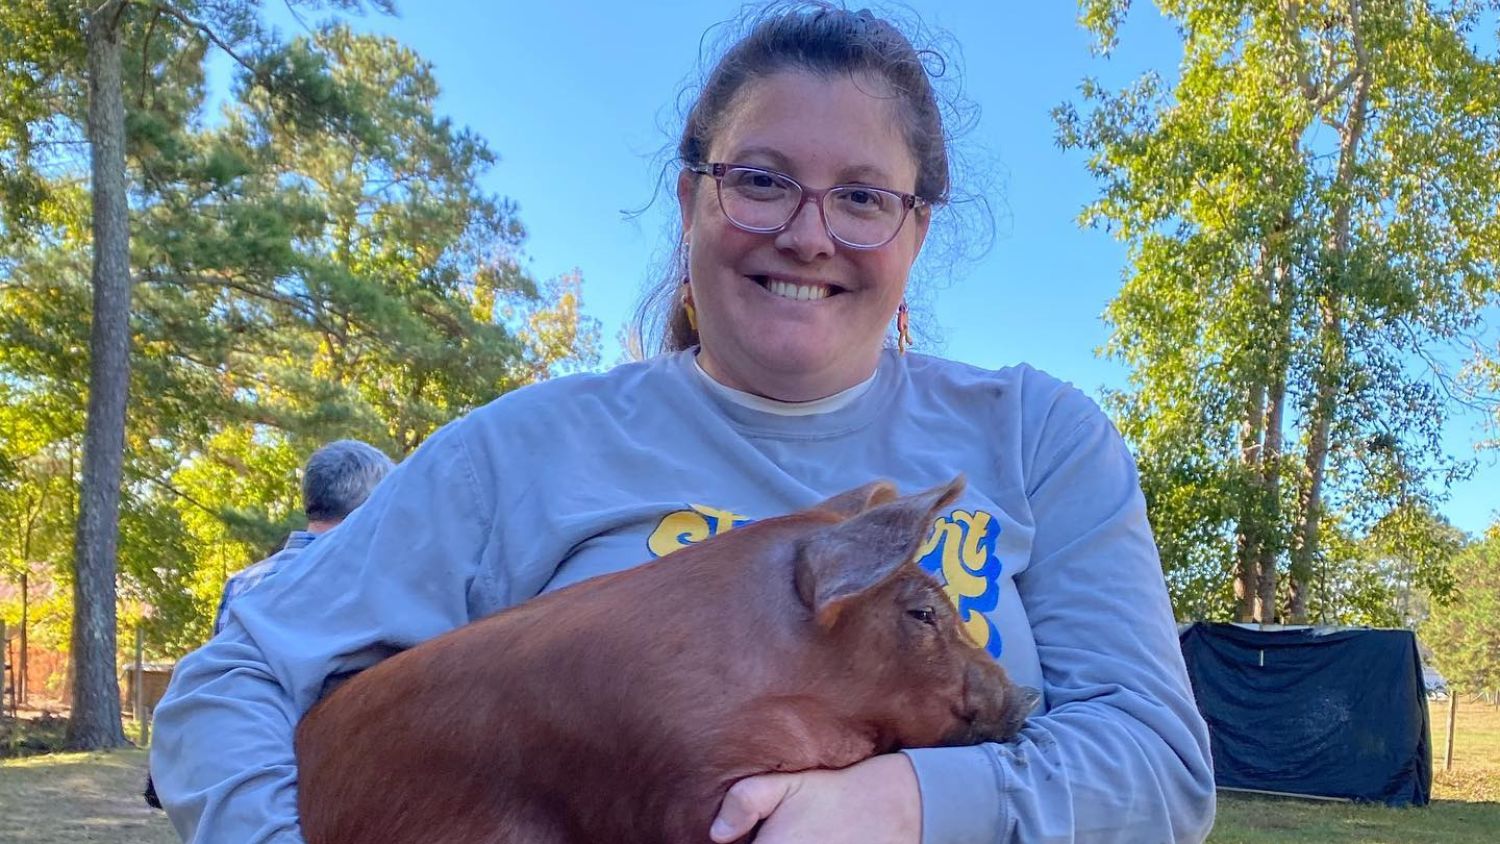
[0,0,393,748]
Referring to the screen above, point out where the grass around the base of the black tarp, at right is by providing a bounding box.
[1209,702,1500,844]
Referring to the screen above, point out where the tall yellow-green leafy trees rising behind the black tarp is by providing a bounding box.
[1055,0,1500,622]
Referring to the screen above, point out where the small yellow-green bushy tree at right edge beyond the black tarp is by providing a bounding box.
[1422,522,1500,694]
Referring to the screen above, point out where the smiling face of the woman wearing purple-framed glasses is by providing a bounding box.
[678,72,927,402]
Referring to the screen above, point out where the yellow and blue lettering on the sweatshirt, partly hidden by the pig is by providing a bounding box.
[647,504,1002,658]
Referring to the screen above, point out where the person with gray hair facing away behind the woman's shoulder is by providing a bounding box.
[213,439,396,636]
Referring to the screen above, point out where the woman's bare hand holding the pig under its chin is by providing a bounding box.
[710,753,923,844]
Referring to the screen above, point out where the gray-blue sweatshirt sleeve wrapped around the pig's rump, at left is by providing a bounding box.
[152,420,494,844]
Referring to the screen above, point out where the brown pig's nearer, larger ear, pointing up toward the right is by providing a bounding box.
[795,475,963,628]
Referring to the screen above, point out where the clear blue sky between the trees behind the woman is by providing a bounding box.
[258,0,1500,532]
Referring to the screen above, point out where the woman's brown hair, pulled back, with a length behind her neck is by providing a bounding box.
[635,1,950,352]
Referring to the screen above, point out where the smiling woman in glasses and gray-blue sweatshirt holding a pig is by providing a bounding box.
[153,6,1214,844]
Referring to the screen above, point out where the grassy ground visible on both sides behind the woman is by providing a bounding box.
[0,702,1500,844]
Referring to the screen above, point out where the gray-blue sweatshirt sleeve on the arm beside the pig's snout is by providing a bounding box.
[908,393,1215,844]
